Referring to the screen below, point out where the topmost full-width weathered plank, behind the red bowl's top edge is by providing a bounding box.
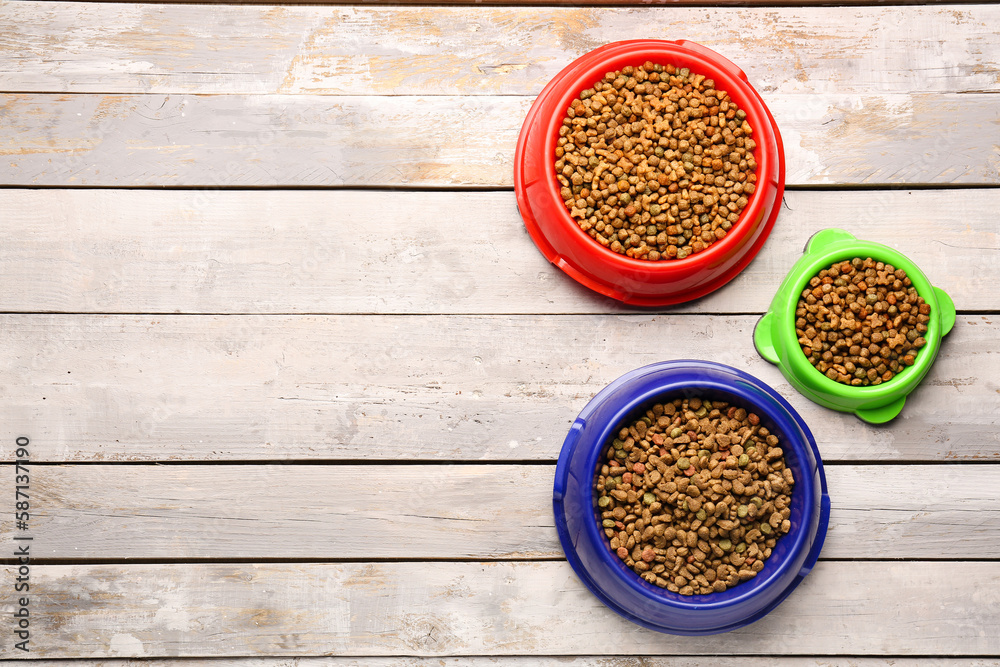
[0,0,1000,96]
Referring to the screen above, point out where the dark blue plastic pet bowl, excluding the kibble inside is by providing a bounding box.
[552,360,830,635]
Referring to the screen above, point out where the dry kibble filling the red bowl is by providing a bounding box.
[555,62,757,260]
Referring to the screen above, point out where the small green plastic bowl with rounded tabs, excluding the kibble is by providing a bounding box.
[753,229,955,424]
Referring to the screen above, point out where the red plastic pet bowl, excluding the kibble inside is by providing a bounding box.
[514,40,785,306]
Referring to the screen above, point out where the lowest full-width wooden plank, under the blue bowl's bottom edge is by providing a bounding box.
[0,561,1000,658]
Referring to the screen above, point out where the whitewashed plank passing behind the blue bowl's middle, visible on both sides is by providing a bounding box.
[0,465,1000,561]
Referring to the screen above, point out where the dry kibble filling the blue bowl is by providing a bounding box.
[596,398,795,595]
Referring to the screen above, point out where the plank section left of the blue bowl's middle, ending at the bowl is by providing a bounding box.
[0,465,556,560]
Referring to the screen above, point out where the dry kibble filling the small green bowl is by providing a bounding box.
[795,257,931,387]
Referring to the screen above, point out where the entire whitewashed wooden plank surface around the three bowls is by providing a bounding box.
[0,1,1000,667]
